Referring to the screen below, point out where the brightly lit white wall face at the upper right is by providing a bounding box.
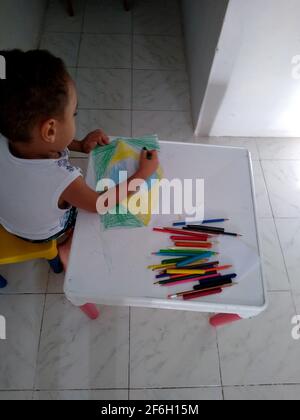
[197,0,300,137]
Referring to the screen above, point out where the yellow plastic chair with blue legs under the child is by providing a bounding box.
[0,225,63,288]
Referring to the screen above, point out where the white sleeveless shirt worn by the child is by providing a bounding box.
[0,136,82,240]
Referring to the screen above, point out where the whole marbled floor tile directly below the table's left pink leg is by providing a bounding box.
[36,295,129,390]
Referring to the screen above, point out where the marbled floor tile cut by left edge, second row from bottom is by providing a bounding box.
[0,295,44,390]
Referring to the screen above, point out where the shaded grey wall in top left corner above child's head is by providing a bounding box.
[0,0,46,50]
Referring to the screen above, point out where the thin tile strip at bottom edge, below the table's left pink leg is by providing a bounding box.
[34,389,128,401]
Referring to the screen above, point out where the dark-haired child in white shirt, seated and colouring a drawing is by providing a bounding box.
[0,50,158,242]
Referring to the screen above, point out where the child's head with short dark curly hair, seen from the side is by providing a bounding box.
[0,50,77,152]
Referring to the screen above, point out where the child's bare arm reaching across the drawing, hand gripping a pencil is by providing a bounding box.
[60,151,159,213]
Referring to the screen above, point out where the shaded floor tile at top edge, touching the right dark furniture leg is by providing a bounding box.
[83,0,132,34]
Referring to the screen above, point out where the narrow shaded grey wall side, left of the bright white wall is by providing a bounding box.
[182,0,228,125]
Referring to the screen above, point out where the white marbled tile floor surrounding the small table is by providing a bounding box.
[0,0,300,400]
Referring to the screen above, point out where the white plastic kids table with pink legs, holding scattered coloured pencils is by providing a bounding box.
[64,142,267,325]
